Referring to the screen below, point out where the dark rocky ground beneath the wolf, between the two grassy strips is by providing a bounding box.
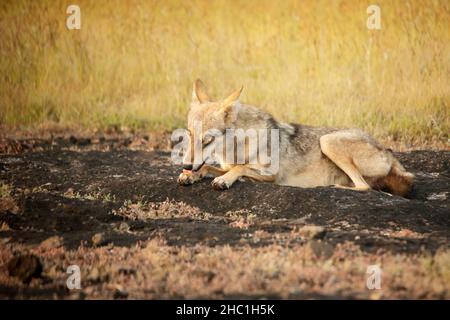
[0,138,450,298]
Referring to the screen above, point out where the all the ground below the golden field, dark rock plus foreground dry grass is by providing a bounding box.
[0,136,450,298]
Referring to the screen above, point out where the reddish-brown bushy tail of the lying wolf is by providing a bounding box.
[382,158,414,197]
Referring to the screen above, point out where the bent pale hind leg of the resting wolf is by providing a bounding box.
[320,130,392,191]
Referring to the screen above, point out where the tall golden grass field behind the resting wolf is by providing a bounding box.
[0,0,450,143]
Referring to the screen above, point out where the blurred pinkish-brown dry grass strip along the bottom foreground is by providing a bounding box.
[0,239,450,299]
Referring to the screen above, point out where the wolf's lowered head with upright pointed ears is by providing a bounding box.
[183,79,243,171]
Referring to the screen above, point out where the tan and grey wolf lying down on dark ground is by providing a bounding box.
[178,79,414,196]
